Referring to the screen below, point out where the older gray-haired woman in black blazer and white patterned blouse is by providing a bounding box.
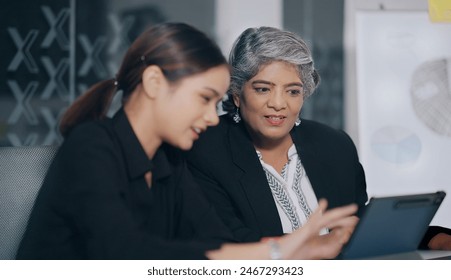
[188,27,450,249]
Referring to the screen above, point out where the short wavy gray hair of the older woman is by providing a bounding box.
[222,26,320,115]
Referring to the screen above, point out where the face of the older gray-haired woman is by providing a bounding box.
[234,61,304,143]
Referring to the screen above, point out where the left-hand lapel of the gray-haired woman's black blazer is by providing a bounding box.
[229,124,283,236]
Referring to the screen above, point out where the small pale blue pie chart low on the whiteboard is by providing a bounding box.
[371,126,421,164]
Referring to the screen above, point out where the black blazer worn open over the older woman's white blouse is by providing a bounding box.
[187,116,368,241]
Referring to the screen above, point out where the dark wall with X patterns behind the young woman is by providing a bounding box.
[0,0,215,146]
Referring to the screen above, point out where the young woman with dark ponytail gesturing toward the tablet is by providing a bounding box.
[17,23,356,259]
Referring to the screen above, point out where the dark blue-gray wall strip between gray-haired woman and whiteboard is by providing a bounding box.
[283,0,344,129]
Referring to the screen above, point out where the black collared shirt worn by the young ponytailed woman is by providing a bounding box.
[17,110,231,259]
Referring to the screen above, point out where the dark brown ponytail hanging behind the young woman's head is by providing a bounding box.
[59,79,117,137]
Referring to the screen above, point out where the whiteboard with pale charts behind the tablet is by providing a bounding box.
[355,10,451,227]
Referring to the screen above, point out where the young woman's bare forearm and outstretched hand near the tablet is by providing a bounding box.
[206,200,357,260]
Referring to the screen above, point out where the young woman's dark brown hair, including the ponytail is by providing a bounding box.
[60,23,227,137]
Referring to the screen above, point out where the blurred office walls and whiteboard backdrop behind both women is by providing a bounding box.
[0,0,451,227]
